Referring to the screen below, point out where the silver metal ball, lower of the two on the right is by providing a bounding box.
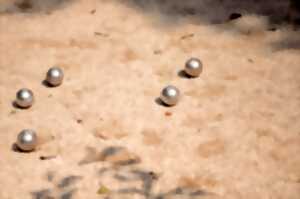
[160,85,180,106]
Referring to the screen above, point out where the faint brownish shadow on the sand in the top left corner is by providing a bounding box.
[0,0,76,14]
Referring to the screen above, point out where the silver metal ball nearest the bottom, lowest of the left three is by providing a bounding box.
[17,129,37,151]
